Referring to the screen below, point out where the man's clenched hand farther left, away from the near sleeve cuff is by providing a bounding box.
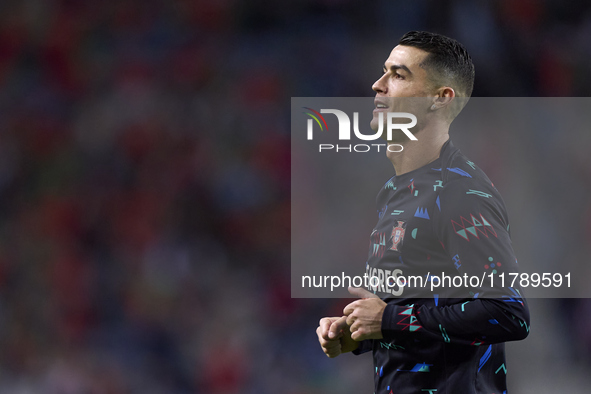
[316,316,359,358]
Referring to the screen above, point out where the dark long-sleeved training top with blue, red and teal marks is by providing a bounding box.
[354,141,529,394]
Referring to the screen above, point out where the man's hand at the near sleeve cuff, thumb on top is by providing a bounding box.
[343,287,387,341]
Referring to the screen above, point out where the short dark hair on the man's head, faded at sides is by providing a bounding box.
[398,31,474,97]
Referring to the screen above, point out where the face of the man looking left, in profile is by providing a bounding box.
[371,45,433,130]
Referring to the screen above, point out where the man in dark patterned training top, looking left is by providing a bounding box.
[317,32,529,394]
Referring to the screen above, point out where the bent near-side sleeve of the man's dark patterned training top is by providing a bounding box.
[382,180,529,345]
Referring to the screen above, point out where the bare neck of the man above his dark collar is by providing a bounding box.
[386,124,449,175]
